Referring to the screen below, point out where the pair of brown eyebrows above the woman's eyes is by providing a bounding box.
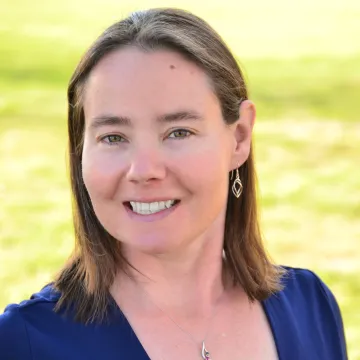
[90,110,203,129]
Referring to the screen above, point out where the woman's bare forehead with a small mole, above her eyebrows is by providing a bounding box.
[84,47,219,116]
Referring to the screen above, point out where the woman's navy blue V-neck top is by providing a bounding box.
[0,268,347,360]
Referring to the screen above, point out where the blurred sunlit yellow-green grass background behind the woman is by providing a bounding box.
[0,0,360,359]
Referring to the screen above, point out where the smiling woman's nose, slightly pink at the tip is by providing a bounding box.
[126,147,166,183]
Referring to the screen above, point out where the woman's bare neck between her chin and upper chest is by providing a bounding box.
[110,236,225,316]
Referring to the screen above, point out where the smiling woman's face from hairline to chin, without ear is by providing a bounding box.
[82,47,245,254]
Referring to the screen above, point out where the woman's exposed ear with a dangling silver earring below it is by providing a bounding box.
[229,100,256,171]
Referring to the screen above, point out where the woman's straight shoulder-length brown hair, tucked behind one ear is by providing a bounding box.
[55,9,283,322]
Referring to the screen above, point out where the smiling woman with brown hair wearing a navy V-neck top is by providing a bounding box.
[0,9,347,360]
